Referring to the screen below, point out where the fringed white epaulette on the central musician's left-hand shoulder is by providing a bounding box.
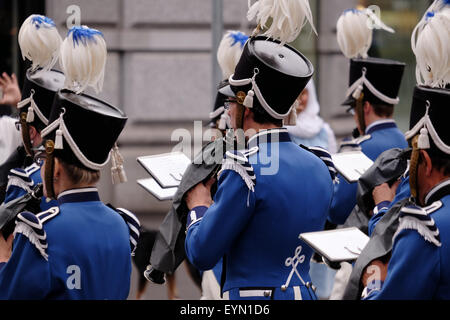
[218,147,259,192]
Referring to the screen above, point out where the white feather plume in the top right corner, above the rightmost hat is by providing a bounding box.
[411,1,450,88]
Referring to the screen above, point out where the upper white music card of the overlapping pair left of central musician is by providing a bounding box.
[137,152,191,188]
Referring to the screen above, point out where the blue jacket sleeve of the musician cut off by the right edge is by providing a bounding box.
[367,229,440,300]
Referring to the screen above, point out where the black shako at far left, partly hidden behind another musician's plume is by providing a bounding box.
[17,69,65,131]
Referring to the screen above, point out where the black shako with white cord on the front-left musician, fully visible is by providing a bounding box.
[42,90,128,170]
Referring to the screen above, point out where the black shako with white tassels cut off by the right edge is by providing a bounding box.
[405,86,450,156]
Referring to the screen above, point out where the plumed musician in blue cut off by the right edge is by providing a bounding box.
[362,0,450,300]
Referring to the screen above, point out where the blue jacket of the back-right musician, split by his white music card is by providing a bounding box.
[330,120,408,224]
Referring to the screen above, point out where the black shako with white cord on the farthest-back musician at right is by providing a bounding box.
[342,58,405,106]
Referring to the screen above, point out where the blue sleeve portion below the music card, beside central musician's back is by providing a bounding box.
[329,174,357,224]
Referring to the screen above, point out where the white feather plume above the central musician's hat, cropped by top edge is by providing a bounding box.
[247,0,317,43]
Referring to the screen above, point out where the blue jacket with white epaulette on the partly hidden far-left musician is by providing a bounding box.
[4,163,58,211]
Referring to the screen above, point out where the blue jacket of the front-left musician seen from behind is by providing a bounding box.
[0,188,138,300]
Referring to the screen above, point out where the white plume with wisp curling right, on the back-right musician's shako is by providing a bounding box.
[336,9,394,59]
